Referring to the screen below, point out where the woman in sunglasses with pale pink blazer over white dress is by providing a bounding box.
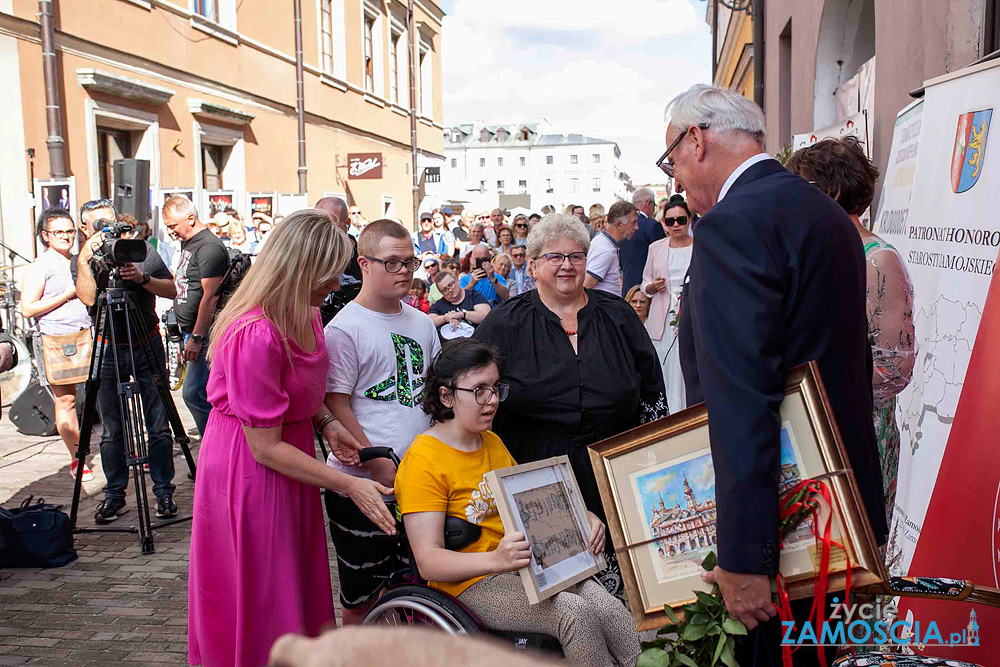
[642,195,694,412]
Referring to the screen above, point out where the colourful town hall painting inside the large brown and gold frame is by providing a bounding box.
[630,422,811,583]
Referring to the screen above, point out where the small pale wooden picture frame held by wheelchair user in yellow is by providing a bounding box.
[486,456,606,604]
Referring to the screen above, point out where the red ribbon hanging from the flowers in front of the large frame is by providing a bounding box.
[777,479,851,667]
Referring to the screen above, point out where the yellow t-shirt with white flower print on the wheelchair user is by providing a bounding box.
[396,431,517,596]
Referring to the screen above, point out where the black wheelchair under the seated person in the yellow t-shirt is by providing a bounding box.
[323,447,563,658]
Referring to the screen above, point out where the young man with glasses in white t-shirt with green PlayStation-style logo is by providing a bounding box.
[324,220,441,625]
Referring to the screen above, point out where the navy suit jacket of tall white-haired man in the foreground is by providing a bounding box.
[679,160,888,575]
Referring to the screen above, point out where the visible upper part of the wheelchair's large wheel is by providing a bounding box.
[362,585,482,635]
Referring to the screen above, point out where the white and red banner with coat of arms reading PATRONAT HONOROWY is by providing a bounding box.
[877,62,1000,664]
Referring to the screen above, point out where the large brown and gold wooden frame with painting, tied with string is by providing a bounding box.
[589,362,886,630]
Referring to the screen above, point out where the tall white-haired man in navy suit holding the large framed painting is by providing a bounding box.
[658,85,887,665]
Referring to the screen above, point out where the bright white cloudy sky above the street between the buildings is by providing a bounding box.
[441,0,712,184]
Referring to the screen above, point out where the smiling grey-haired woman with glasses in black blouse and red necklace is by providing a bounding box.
[475,213,667,595]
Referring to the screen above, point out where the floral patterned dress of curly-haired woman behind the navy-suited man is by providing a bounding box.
[865,236,916,524]
